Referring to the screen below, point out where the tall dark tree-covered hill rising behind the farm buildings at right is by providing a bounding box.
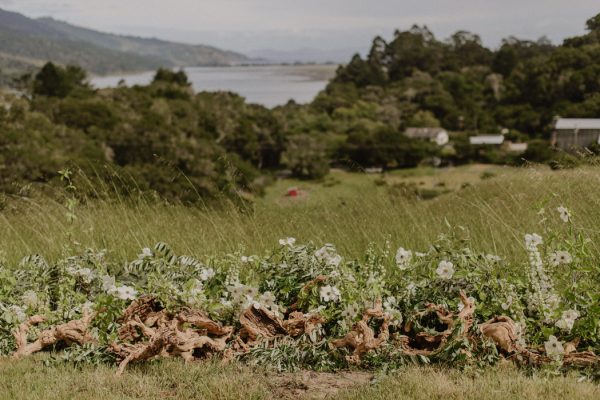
[322,15,600,138]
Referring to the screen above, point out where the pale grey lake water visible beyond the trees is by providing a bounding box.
[91,65,336,108]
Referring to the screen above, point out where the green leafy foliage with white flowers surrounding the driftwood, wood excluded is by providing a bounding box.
[0,206,600,371]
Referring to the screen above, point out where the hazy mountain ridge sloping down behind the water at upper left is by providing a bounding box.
[0,9,251,79]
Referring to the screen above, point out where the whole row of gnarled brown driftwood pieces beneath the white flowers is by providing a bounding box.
[12,288,600,375]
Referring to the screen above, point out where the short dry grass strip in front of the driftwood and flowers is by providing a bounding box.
[0,356,600,400]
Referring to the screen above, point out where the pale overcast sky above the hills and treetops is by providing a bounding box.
[0,0,600,53]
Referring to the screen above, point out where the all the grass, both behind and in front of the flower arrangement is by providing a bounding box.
[0,166,600,399]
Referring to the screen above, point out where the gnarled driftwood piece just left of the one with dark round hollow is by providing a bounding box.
[331,299,390,364]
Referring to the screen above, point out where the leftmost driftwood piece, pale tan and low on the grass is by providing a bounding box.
[12,310,96,358]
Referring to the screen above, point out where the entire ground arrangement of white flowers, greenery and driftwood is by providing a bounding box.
[0,207,600,378]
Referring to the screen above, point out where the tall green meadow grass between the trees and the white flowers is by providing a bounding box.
[0,162,600,263]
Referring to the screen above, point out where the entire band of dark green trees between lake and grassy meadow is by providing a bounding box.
[0,15,600,201]
